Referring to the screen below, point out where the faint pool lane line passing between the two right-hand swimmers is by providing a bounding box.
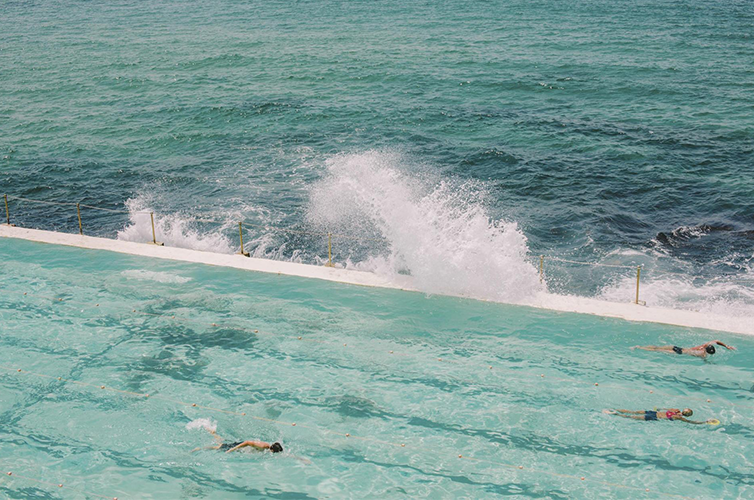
[11,292,754,411]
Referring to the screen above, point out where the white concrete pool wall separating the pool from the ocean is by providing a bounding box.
[0,225,754,335]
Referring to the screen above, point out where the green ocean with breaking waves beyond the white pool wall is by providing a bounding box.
[0,0,754,317]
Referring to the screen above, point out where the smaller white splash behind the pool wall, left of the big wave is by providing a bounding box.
[117,195,234,253]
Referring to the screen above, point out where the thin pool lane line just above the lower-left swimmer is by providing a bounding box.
[0,365,694,500]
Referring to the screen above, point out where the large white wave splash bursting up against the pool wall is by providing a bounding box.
[308,151,542,302]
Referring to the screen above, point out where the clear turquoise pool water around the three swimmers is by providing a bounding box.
[0,240,754,498]
